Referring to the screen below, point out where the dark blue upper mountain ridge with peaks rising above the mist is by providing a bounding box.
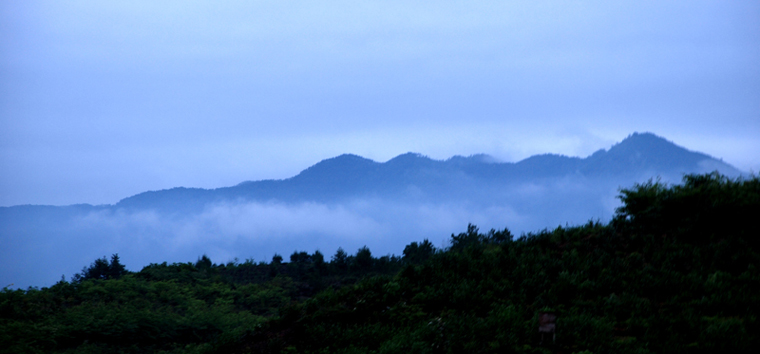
[115,133,741,210]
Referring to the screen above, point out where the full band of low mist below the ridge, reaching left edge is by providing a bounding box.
[0,177,619,288]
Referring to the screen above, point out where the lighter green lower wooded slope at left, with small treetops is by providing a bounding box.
[0,247,401,353]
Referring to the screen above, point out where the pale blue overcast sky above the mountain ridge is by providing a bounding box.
[0,0,760,206]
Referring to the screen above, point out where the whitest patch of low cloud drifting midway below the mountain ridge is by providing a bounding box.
[74,199,519,265]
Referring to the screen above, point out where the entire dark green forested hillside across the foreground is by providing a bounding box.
[0,174,760,353]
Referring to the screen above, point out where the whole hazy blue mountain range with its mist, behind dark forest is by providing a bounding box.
[0,133,741,287]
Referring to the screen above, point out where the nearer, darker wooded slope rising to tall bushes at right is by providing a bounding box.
[245,175,760,353]
